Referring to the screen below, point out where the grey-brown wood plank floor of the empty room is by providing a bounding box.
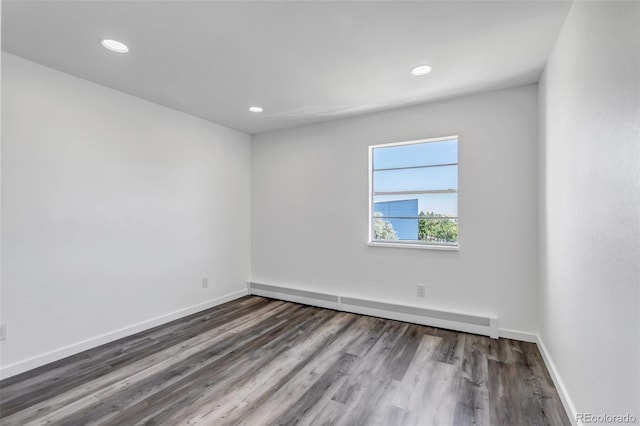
[0,296,570,426]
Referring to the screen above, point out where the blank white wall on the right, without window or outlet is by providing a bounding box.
[540,1,640,419]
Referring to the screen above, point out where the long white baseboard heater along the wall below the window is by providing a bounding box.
[247,282,498,339]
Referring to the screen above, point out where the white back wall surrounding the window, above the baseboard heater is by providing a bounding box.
[252,85,538,333]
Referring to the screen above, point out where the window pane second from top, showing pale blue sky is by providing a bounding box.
[373,165,458,192]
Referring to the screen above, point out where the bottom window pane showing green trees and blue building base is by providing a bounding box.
[373,215,458,246]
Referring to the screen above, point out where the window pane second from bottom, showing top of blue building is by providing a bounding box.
[373,194,458,217]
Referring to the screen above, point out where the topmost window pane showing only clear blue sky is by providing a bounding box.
[373,139,458,169]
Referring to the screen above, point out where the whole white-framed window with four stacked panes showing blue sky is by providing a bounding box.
[369,136,458,248]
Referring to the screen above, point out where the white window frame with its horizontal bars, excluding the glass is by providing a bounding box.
[367,135,460,251]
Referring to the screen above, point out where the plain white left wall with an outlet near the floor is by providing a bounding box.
[1,53,251,373]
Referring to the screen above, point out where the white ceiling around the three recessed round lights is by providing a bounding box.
[2,0,571,133]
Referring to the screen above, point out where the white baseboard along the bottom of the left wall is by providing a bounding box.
[0,290,249,379]
